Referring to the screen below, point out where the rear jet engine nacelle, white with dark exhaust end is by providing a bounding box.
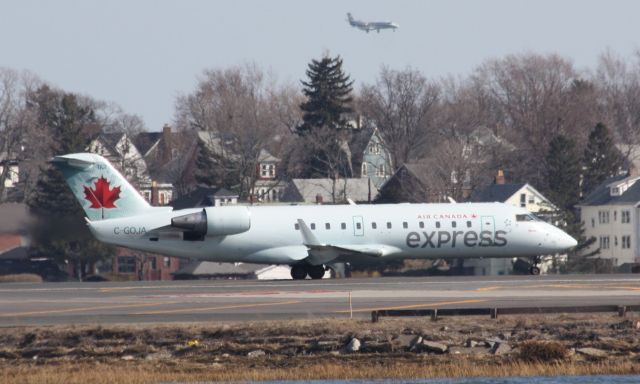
[171,207,251,237]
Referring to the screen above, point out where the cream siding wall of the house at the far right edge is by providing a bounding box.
[581,205,640,265]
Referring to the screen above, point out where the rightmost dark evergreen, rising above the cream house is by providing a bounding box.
[582,123,623,196]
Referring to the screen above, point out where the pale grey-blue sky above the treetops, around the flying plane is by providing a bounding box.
[0,0,640,131]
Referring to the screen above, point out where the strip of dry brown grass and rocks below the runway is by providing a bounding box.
[0,315,640,383]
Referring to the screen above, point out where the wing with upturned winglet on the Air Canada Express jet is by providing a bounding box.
[298,219,401,265]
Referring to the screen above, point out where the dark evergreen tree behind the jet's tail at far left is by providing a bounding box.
[27,86,114,278]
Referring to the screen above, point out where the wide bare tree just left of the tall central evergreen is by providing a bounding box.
[176,64,297,197]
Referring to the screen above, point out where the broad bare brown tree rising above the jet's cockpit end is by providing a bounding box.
[472,54,595,185]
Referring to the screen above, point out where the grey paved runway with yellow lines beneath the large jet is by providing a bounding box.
[0,275,640,326]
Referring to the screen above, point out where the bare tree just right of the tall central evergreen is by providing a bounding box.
[359,67,441,167]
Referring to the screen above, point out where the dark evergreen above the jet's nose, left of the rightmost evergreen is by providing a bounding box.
[545,134,581,211]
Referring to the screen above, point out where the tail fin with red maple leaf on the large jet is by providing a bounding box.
[52,153,153,221]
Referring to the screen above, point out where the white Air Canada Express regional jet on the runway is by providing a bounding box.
[53,153,576,279]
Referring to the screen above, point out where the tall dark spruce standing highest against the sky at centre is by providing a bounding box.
[297,56,353,135]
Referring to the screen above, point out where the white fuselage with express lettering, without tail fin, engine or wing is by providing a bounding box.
[89,203,575,264]
